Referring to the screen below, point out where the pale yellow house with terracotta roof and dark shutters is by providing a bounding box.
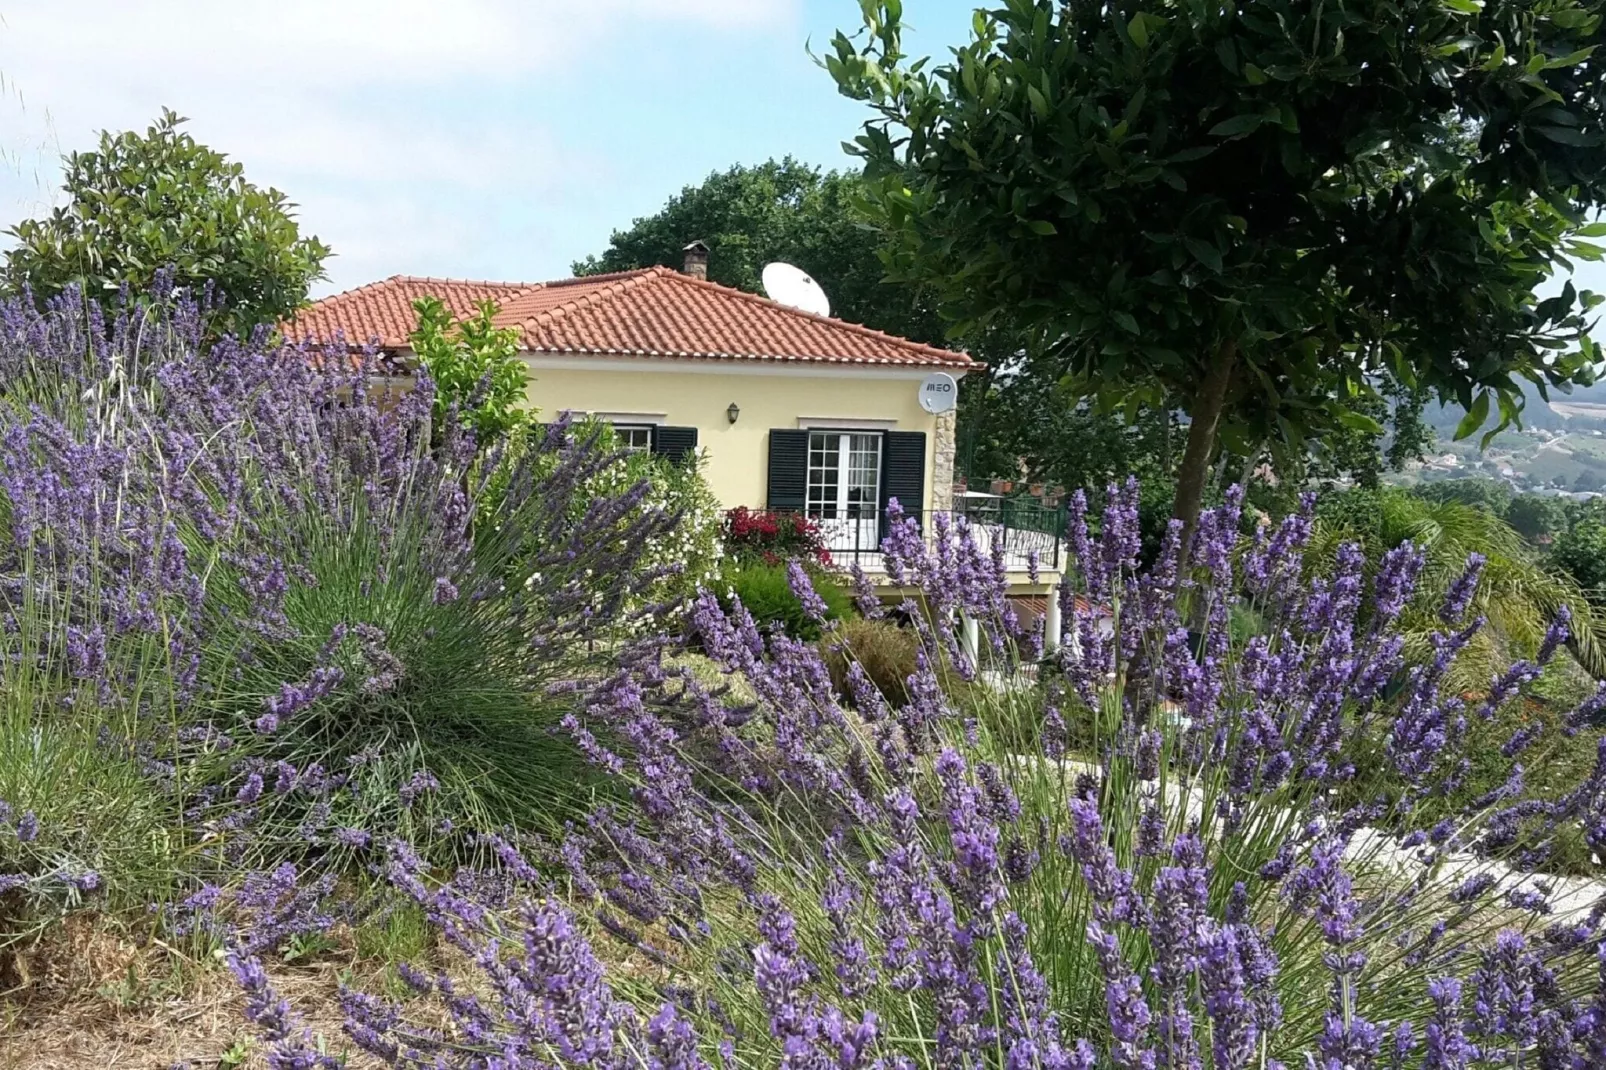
[286,246,1062,613]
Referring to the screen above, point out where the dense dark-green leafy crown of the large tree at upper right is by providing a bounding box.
[825,0,1606,524]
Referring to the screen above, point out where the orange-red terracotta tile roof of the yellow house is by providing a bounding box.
[286,267,980,368]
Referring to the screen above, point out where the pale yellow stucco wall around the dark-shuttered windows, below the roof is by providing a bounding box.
[530,355,952,508]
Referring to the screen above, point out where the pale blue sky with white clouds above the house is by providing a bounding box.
[0,0,1606,303]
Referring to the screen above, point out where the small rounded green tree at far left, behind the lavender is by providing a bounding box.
[5,109,329,334]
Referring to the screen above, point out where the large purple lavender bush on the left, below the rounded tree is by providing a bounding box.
[0,281,675,864]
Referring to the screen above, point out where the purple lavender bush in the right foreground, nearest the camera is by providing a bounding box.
[253,487,1606,1070]
